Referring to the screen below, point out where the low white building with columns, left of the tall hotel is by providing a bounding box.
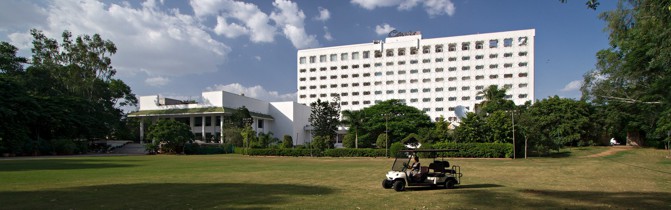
[128,91,311,145]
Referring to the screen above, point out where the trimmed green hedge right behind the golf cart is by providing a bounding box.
[432,142,513,158]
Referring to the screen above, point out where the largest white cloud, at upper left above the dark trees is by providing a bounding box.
[11,1,230,81]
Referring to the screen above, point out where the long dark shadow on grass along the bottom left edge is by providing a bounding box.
[0,183,334,209]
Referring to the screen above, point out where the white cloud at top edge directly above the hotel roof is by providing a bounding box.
[350,0,456,17]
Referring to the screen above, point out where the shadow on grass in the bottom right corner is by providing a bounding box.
[457,189,671,209]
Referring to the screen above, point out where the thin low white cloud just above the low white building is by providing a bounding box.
[205,83,296,102]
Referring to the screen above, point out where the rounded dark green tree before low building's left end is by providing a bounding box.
[147,119,193,153]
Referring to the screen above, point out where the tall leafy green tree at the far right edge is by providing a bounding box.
[582,0,671,145]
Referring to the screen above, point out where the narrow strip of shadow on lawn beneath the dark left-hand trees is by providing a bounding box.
[0,159,135,172]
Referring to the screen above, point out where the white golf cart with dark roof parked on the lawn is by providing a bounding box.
[382,149,462,191]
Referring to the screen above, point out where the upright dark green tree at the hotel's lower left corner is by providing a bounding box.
[309,97,340,148]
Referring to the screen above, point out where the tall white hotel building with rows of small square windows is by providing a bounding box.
[297,29,535,121]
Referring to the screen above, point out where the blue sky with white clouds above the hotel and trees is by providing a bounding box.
[0,0,615,105]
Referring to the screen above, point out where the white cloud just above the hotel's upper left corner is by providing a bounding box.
[270,0,319,49]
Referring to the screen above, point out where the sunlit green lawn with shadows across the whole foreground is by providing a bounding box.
[0,147,671,209]
